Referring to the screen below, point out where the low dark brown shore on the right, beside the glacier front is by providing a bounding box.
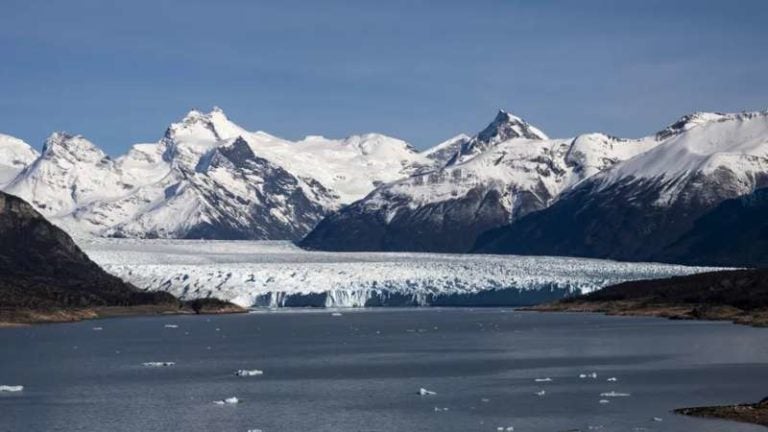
[532,269,768,326]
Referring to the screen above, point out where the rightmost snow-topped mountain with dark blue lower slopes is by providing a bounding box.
[477,112,768,264]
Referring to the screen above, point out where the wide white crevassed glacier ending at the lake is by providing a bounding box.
[79,238,724,307]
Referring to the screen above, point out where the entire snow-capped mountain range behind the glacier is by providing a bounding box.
[0,108,768,265]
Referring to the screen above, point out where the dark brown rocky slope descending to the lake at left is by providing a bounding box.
[0,192,243,323]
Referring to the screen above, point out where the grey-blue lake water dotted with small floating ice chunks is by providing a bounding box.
[0,309,768,432]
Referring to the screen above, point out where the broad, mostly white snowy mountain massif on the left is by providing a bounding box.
[0,108,435,239]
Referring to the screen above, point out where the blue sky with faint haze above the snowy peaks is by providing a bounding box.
[0,0,768,155]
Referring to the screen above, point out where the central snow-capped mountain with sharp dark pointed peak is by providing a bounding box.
[301,111,658,252]
